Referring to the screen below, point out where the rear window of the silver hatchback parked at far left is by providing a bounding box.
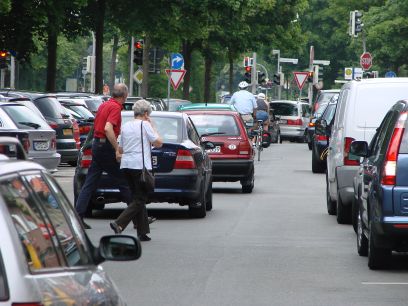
[2,105,50,129]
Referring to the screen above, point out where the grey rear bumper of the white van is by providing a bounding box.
[336,166,359,206]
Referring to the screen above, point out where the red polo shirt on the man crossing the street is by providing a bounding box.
[94,98,122,138]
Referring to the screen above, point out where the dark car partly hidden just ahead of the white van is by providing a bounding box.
[312,96,337,173]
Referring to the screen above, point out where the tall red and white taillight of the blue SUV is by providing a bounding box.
[381,112,408,185]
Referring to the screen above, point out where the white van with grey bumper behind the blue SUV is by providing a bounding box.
[326,78,408,223]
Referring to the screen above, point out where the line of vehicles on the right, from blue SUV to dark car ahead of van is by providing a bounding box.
[312,78,408,269]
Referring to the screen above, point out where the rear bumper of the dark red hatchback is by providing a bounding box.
[212,159,254,182]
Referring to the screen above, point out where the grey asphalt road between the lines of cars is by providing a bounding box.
[55,142,408,306]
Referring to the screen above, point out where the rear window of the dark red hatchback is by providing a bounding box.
[190,114,240,136]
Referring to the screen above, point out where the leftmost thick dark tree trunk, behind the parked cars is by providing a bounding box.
[45,16,58,92]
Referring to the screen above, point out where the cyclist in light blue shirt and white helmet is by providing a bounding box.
[230,81,256,126]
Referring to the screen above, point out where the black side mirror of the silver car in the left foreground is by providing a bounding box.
[99,235,142,261]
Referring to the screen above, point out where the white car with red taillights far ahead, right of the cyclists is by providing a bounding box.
[269,100,310,142]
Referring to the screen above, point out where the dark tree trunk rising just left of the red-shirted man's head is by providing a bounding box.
[95,0,106,94]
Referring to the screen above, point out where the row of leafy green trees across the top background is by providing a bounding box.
[0,0,408,101]
